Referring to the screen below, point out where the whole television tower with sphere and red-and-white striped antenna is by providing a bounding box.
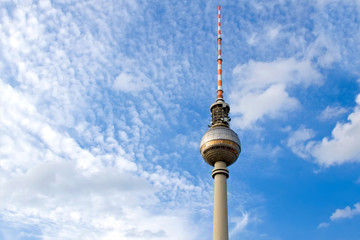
[200,6,241,240]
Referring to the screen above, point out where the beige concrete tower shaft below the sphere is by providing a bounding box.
[213,161,229,240]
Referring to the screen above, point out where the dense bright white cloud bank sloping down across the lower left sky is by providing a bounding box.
[0,78,210,240]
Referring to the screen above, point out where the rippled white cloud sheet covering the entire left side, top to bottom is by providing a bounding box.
[0,1,212,240]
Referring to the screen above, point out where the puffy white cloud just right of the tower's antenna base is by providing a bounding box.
[230,58,321,128]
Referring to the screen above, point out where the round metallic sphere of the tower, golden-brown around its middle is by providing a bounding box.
[200,126,241,166]
